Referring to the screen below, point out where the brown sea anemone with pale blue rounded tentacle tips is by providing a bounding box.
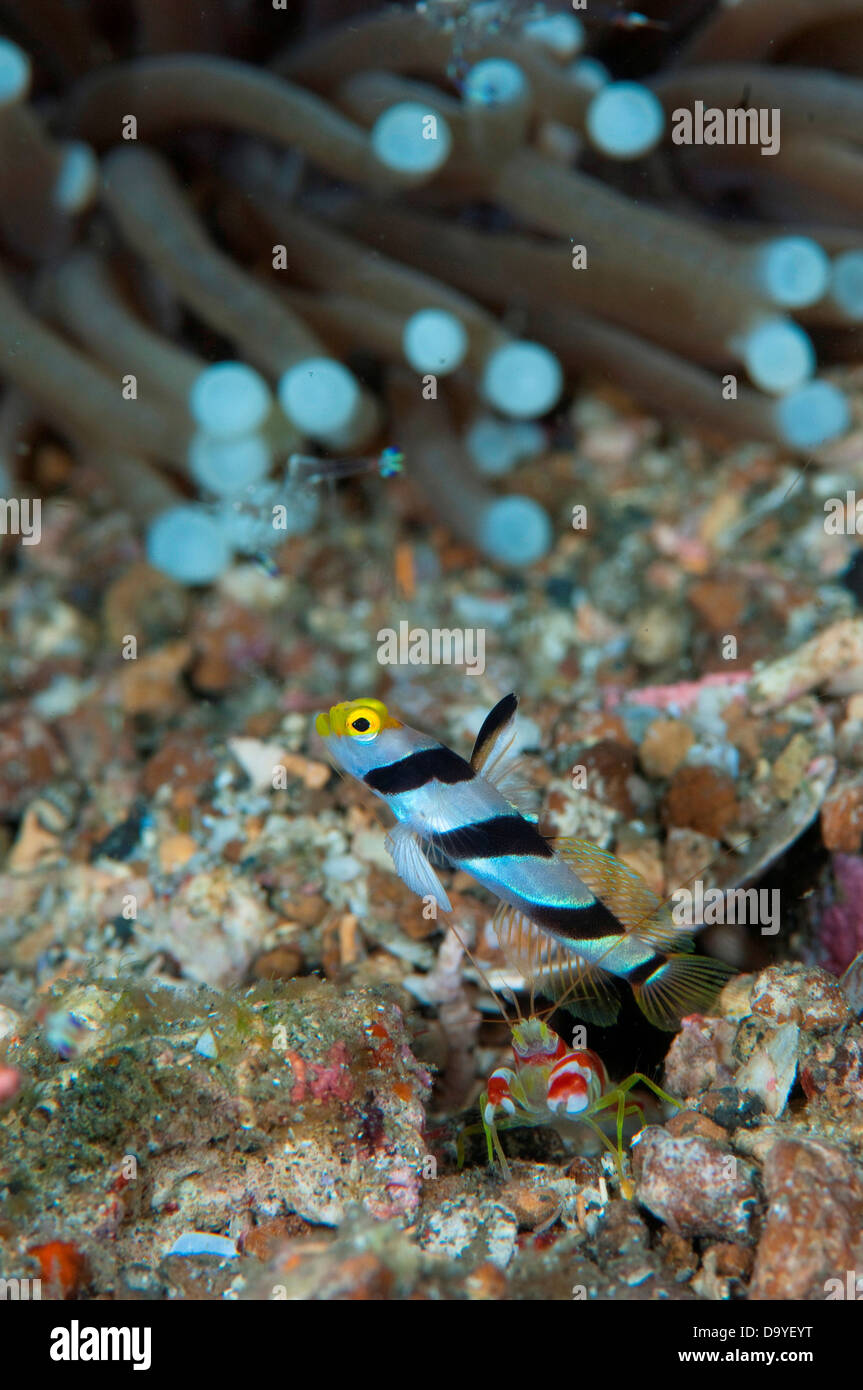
[0,0,863,584]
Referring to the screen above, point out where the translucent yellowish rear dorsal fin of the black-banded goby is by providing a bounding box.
[552,835,692,951]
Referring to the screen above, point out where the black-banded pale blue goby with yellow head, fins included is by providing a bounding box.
[315,695,727,1027]
